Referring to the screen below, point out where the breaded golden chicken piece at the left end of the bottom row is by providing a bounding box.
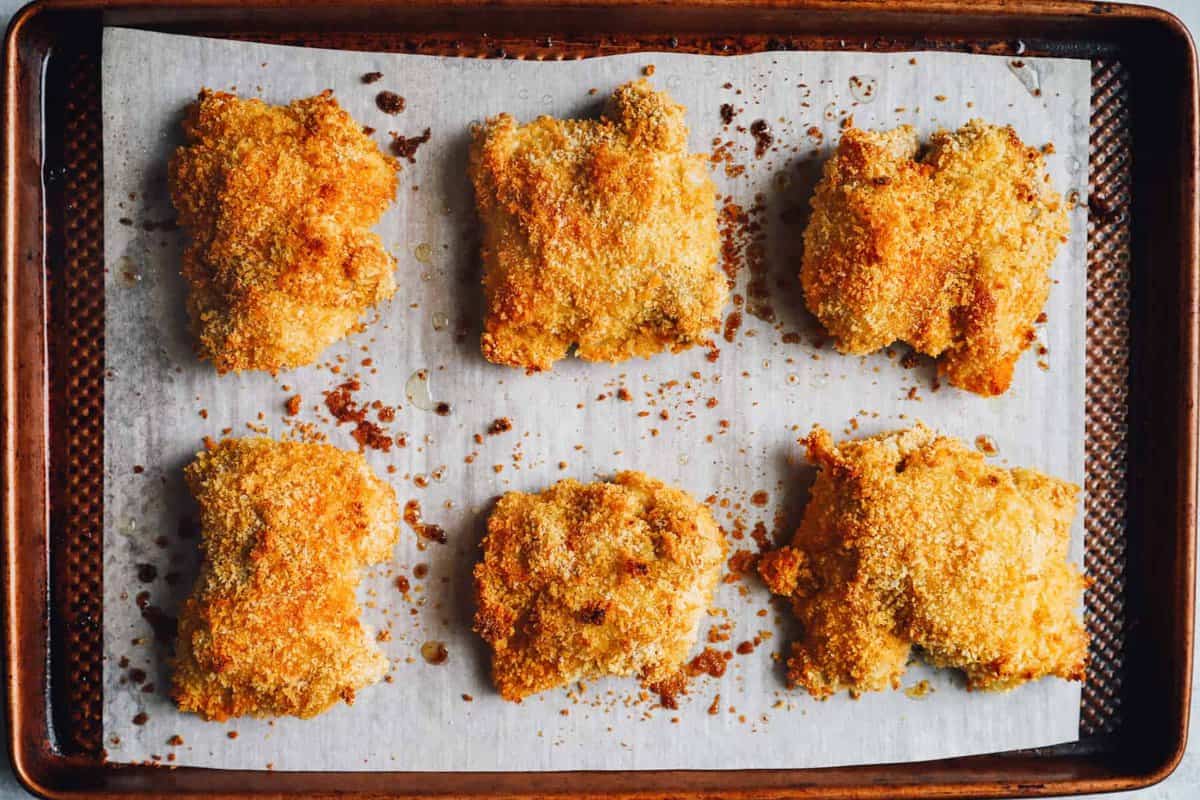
[172,438,400,720]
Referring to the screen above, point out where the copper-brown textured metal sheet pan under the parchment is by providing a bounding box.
[2,0,1198,798]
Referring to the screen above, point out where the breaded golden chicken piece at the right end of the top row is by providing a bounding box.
[800,120,1068,396]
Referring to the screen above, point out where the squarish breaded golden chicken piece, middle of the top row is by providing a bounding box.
[470,80,727,372]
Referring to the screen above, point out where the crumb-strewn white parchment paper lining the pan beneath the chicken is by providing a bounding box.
[102,29,1090,770]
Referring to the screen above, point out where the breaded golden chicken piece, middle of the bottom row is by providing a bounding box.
[475,471,725,700]
